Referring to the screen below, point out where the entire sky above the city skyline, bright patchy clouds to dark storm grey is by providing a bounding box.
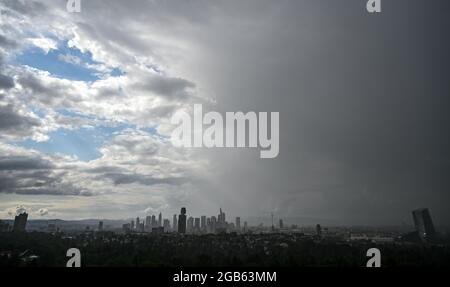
[0,0,450,225]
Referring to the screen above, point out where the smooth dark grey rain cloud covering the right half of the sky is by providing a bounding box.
[182,1,450,224]
